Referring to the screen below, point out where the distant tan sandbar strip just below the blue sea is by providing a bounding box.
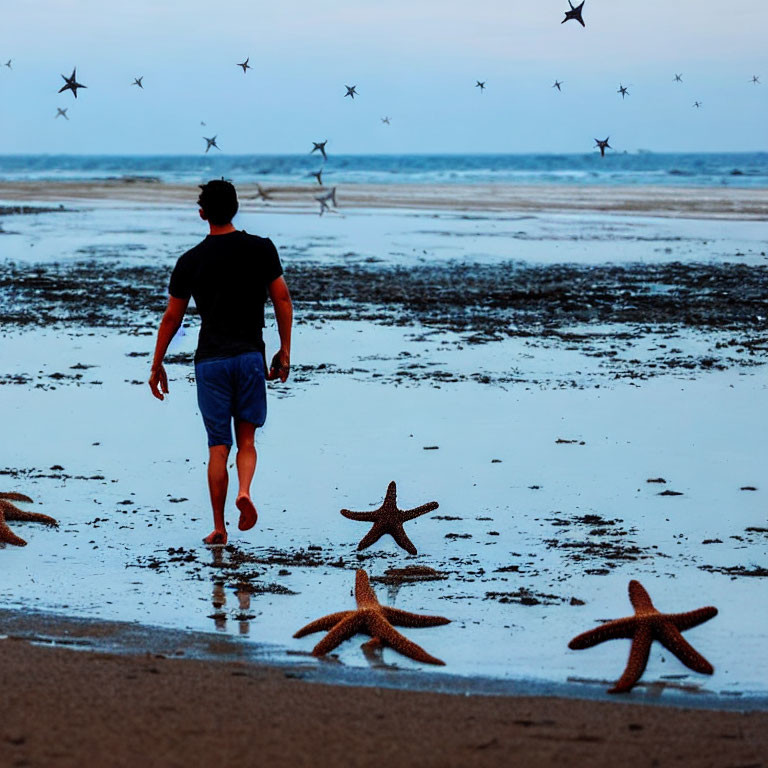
[0,179,768,221]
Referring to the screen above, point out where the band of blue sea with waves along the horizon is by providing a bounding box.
[0,152,768,187]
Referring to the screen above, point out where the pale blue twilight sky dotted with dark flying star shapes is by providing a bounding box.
[0,0,768,154]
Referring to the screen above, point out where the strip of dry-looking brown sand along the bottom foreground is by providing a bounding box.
[0,639,768,768]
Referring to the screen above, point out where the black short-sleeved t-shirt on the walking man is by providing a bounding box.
[168,231,283,362]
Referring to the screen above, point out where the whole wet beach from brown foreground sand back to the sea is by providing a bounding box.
[0,182,768,766]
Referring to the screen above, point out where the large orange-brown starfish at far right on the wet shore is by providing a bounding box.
[568,580,717,693]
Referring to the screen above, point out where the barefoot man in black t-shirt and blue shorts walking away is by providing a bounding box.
[149,179,293,545]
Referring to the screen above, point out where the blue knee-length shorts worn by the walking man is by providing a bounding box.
[195,352,267,446]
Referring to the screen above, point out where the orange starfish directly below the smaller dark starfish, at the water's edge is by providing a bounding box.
[294,568,450,665]
